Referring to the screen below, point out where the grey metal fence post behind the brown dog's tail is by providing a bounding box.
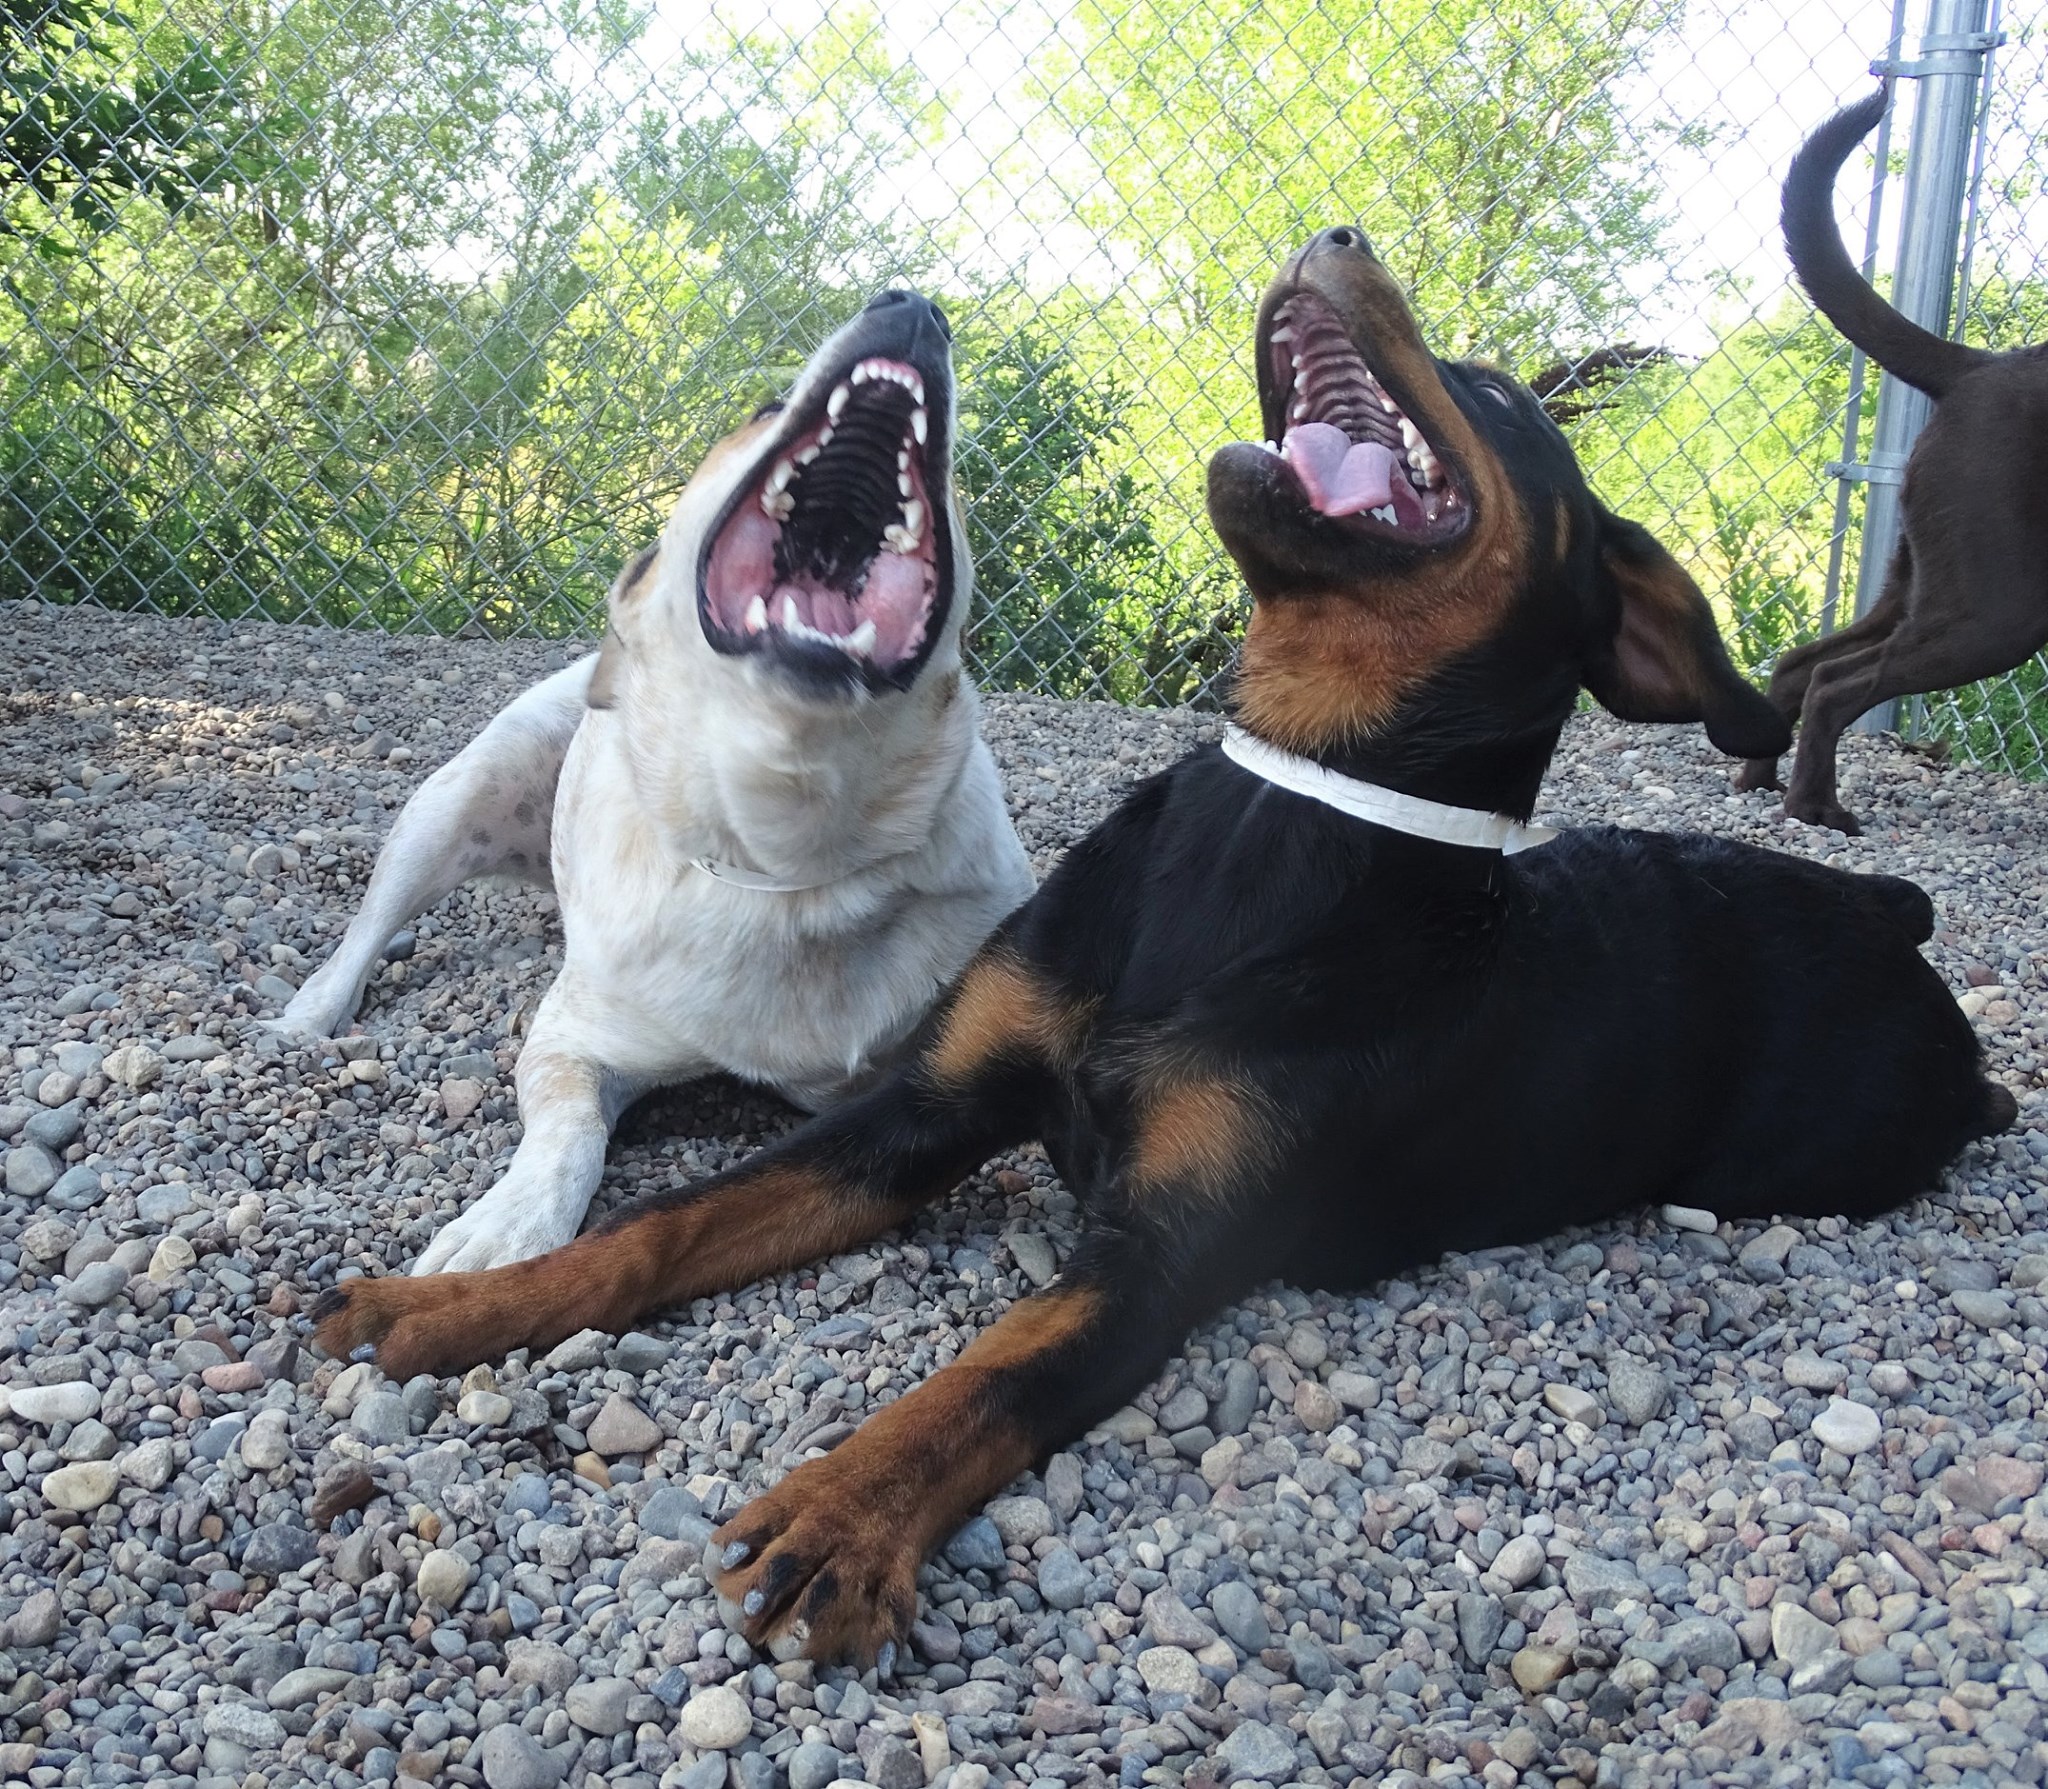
[1855,0,1995,733]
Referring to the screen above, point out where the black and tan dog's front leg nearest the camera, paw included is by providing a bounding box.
[707,1232,1198,1672]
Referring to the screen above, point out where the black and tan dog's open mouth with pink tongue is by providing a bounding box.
[1264,293,1470,544]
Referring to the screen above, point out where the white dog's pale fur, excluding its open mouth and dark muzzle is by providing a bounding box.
[279,321,1032,1273]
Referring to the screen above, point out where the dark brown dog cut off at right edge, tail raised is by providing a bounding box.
[1741,88,2048,833]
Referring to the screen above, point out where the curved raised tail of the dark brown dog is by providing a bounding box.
[1782,82,1997,397]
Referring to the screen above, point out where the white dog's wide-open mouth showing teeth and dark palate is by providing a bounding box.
[702,356,944,680]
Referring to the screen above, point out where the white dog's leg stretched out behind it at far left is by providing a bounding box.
[272,659,596,1038]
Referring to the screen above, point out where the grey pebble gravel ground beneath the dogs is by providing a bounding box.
[0,604,2048,1789]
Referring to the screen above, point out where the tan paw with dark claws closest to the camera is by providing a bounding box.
[707,1443,922,1676]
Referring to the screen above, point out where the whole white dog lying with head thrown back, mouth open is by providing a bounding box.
[279,291,1032,1273]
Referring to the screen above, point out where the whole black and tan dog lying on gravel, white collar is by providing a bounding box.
[317,229,2013,1666]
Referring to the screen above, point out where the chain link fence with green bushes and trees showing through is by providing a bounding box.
[0,0,2048,753]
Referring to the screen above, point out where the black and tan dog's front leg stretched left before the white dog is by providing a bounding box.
[313,942,1090,1380]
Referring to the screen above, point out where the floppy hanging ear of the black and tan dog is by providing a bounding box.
[1585,508,1792,757]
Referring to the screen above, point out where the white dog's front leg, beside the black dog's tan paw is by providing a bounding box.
[412,990,651,1273]
